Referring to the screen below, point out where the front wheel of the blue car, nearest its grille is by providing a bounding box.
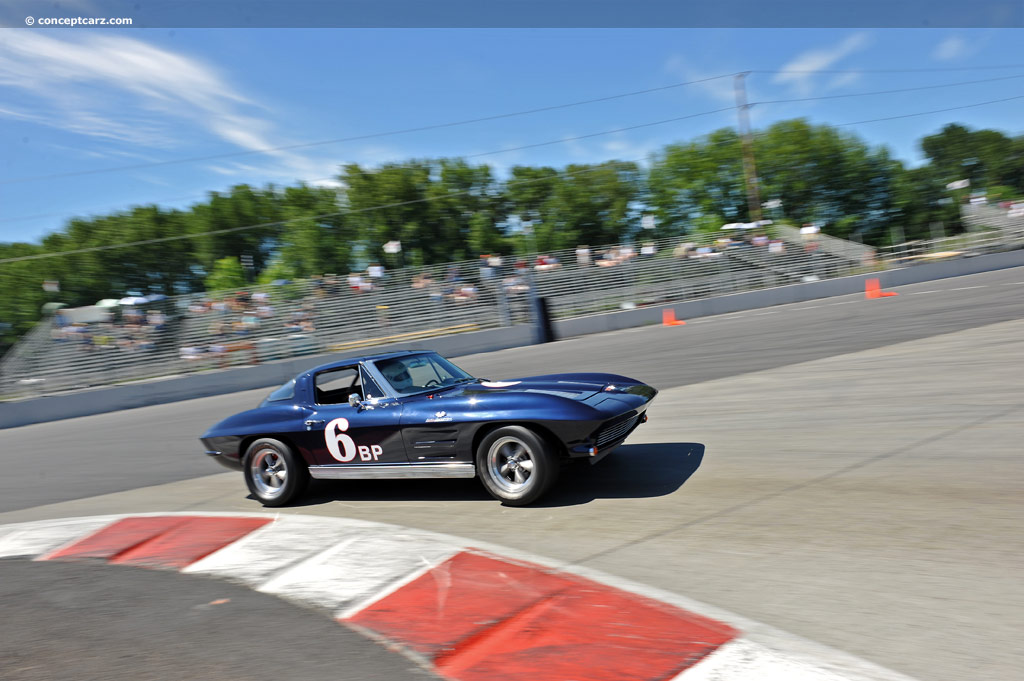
[476,426,560,506]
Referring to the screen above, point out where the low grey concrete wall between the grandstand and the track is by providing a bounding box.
[0,251,1024,428]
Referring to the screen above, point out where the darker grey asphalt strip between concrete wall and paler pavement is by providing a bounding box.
[0,268,1024,513]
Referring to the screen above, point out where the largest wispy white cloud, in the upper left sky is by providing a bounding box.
[0,29,323,175]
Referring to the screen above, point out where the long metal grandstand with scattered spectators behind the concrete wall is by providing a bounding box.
[0,225,872,399]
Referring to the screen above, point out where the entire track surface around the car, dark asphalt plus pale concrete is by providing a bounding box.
[0,268,1024,681]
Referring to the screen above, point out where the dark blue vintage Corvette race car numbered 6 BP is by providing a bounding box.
[201,351,657,506]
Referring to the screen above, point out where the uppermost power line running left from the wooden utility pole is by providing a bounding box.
[0,74,734,184]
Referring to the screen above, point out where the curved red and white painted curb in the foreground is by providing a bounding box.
[0,513,911,681]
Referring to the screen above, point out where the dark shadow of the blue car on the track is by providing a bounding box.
[284,442,705,508]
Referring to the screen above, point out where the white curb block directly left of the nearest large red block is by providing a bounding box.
[257,528,461,610]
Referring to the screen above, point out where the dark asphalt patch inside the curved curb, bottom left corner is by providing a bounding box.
[0,559,438,681]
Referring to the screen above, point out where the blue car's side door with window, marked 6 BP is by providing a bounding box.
[297,365,409,466]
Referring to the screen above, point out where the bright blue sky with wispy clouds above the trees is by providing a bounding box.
[0,28,1024,242]
